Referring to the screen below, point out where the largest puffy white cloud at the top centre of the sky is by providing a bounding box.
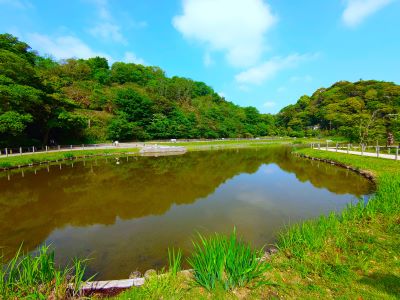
[173,0,277,67]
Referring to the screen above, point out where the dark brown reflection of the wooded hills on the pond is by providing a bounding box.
[0,148,372,260]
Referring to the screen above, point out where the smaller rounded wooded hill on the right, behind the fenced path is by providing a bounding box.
[276,80,400,143]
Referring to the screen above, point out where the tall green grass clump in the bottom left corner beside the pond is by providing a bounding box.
[0,246,89,299]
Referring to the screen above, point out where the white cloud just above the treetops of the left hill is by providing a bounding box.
[27,33,112,61]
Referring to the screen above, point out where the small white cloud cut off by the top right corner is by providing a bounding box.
[342,0,393,27]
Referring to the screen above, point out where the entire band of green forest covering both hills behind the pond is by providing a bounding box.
[0,34,400,146]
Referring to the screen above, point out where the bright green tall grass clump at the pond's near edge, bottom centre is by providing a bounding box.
[188,229,269,290]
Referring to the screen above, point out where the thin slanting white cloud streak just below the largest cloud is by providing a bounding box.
[235,54,317,84]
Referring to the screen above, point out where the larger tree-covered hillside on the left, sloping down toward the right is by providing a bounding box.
[0,34,274,146]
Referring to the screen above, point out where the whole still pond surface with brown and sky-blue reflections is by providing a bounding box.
[0,147,373,279]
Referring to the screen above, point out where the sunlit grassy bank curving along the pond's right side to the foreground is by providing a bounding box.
[115,149,400,299]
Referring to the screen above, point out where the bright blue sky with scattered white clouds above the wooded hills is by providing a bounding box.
[0,0,400,113]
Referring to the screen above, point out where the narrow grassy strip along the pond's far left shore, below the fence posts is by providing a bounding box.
[0,148,139,169]
